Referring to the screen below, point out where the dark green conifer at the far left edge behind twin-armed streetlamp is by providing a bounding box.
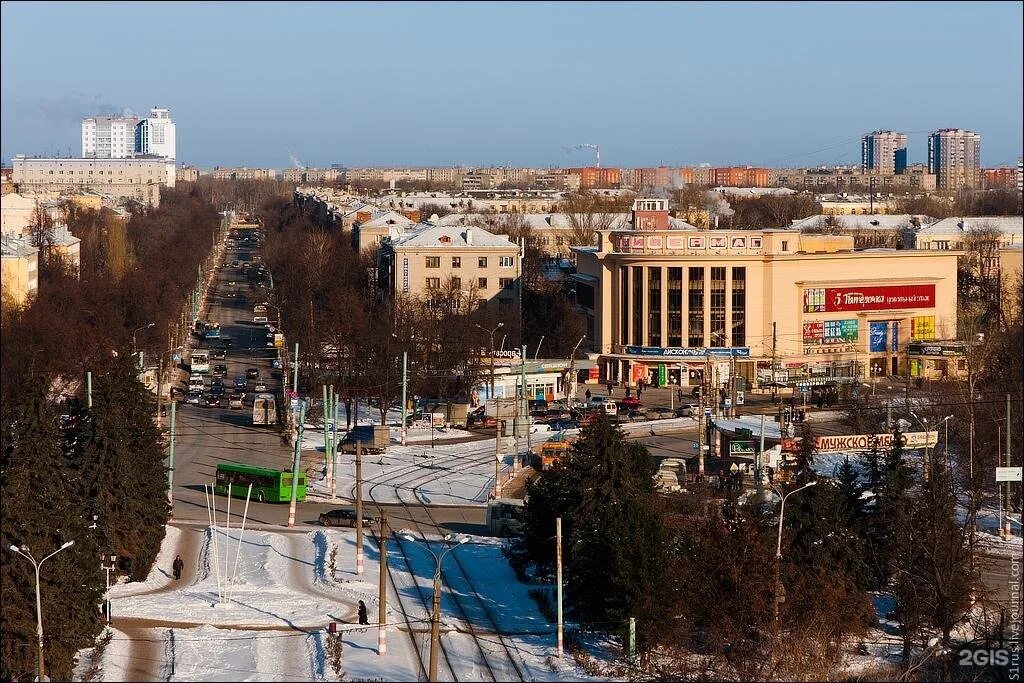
[0,382,103,680]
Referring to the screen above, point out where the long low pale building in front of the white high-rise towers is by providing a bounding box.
[14,157,177,206]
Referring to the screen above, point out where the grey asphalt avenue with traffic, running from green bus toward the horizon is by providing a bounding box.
[167,232,485,533]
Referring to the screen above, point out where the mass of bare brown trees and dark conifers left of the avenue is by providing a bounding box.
[0,188,220,680]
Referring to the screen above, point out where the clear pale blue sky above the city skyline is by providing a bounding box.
[0,2,1024,168]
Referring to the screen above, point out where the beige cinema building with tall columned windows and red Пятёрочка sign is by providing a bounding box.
[572,200,958,388]
